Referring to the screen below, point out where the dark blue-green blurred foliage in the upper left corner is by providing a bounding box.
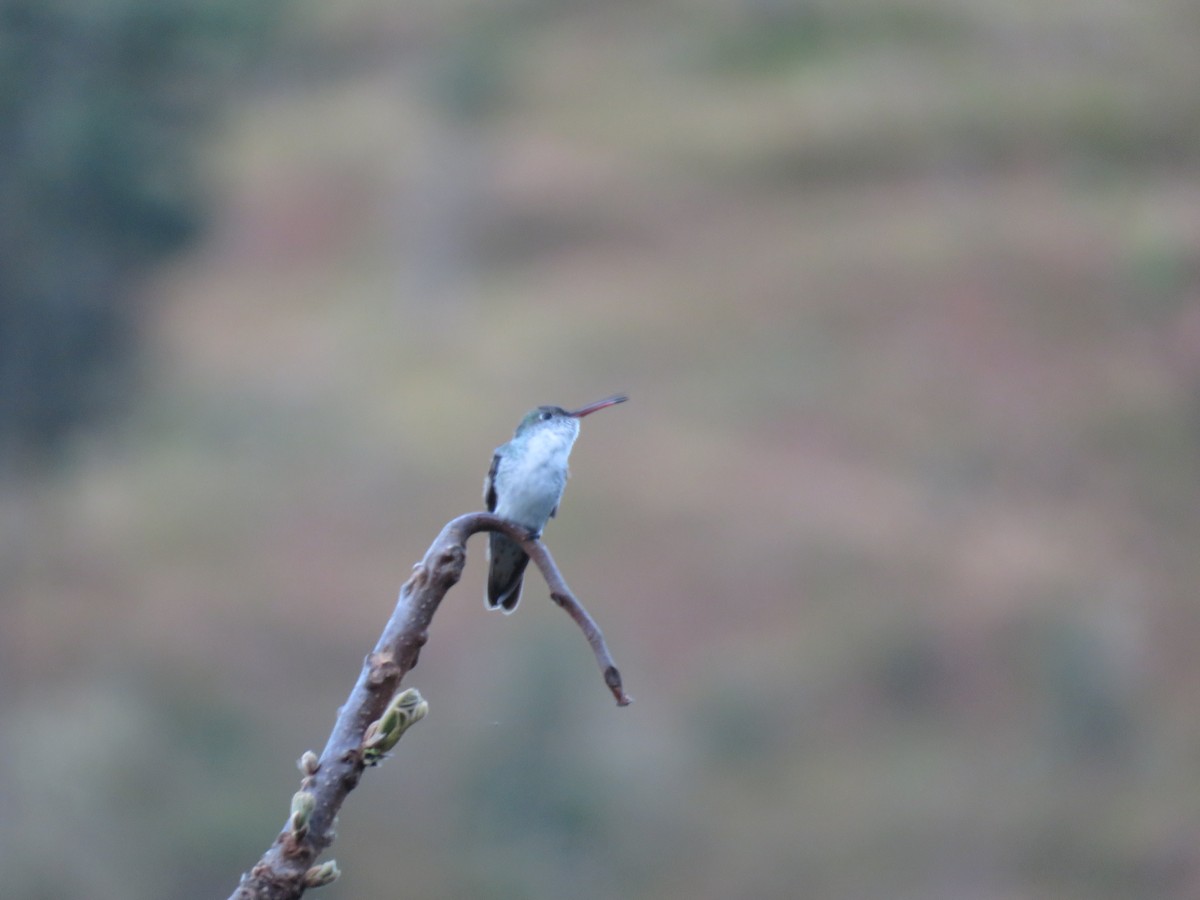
[0,0,275,465]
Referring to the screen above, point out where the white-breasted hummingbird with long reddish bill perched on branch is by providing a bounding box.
[484,394,629,613]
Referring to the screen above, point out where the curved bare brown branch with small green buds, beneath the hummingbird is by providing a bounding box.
[230,512,631,900]
